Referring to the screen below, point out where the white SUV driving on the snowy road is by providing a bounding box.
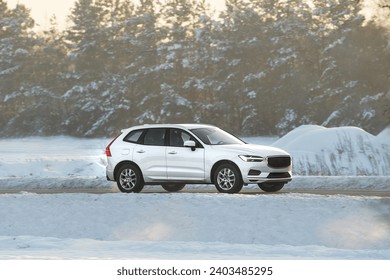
[106,124,291,193]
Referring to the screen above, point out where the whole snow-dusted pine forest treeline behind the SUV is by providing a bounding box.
[0,0,390,137]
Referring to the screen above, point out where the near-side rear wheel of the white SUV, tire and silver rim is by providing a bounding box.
[116,163,144,193]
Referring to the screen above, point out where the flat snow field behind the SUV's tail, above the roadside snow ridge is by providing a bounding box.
[0,136,107,178]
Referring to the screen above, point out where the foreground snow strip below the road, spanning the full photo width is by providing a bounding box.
[0,193,390,259]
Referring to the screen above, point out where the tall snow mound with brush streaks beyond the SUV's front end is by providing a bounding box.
[273,125,390,176]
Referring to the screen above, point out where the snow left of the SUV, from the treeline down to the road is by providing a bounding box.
[0,136,111,191]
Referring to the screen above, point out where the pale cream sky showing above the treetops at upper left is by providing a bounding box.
[7,0,224,29]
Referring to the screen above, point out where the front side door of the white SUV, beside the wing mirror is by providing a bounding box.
[166,128,205,182]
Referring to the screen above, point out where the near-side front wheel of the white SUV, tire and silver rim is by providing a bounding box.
[213,163,243,193]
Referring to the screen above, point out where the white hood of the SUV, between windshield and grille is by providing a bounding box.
[213,144,289,157]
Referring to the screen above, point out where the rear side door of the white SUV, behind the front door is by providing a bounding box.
[133,128,167,182]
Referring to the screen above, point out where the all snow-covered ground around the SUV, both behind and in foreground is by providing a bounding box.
[0,126,390,259]
